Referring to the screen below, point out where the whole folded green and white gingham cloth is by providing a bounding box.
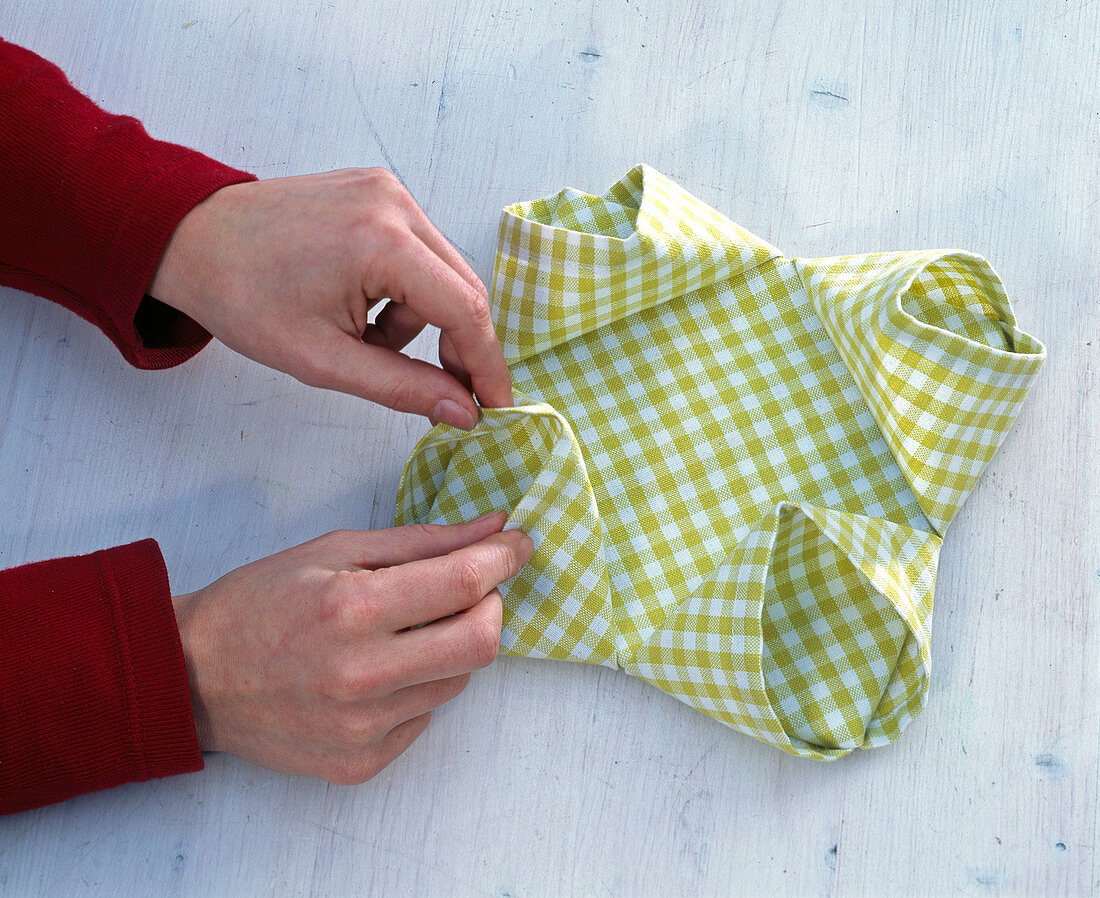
[397,166,1045,759]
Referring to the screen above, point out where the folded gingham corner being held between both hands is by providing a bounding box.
[396,397,616,667]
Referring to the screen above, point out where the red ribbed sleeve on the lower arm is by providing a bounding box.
[0,539,202,813]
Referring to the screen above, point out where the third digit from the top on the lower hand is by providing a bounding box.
[392,590,504,687]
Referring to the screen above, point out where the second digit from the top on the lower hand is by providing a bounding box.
[375,530,534,632]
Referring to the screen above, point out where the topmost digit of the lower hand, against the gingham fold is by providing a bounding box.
[321,512,508,570]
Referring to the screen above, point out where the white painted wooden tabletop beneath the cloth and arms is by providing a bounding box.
[0,0,1100,898]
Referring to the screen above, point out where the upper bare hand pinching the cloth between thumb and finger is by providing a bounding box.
[149,168,512,429]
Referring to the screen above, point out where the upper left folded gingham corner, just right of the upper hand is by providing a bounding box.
[493,165,780,362]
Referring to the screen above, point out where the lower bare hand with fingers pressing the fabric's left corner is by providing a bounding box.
[173,513,531,784]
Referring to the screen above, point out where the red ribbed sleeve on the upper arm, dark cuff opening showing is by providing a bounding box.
[0,40,255,369]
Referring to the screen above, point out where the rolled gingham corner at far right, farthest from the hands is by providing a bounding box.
[794,250,1046,535]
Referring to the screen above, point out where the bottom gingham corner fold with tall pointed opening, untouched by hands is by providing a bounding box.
[624,502,939,760]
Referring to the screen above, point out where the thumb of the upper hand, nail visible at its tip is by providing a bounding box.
[299,330,477,430]
